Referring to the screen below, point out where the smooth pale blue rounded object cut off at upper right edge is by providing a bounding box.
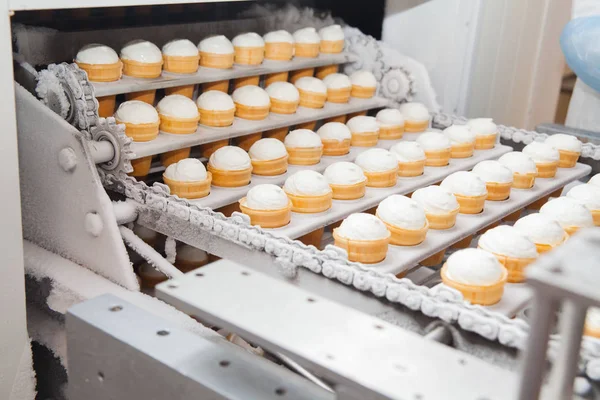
[560,16,600,92]
